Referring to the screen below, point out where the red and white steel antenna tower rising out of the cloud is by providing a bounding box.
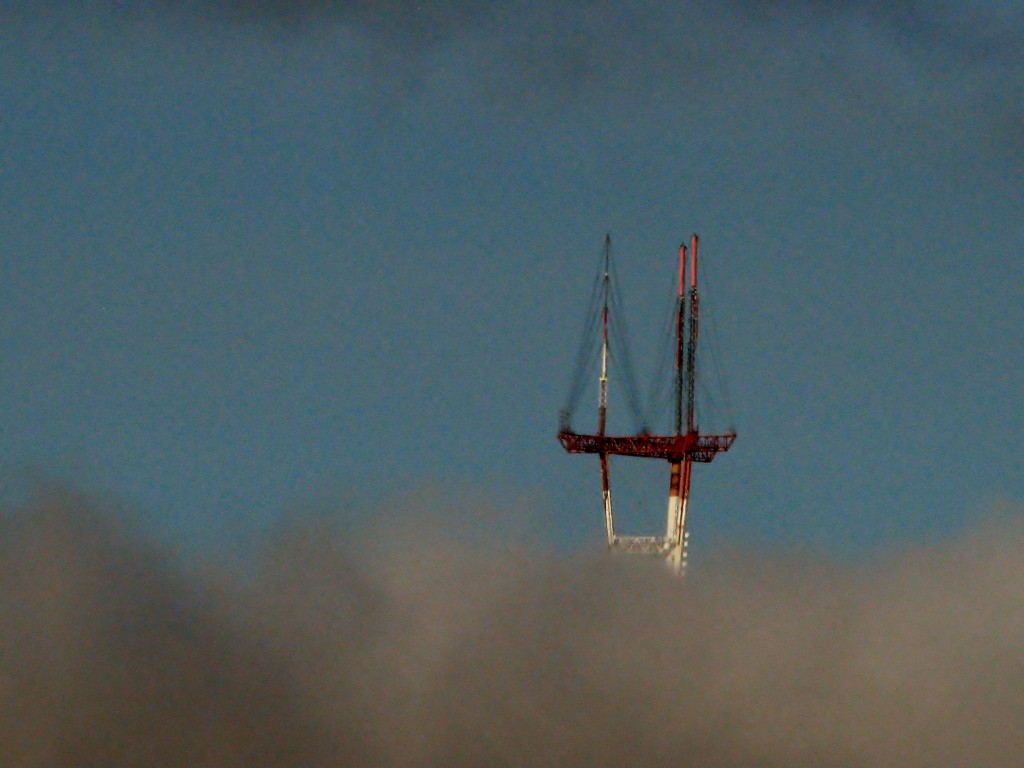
[558,234,736,572]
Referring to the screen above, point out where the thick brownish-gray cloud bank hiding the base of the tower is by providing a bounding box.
[0,489,1024,768]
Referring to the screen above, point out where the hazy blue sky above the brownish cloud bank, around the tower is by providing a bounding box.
[0,0,1024,556]
